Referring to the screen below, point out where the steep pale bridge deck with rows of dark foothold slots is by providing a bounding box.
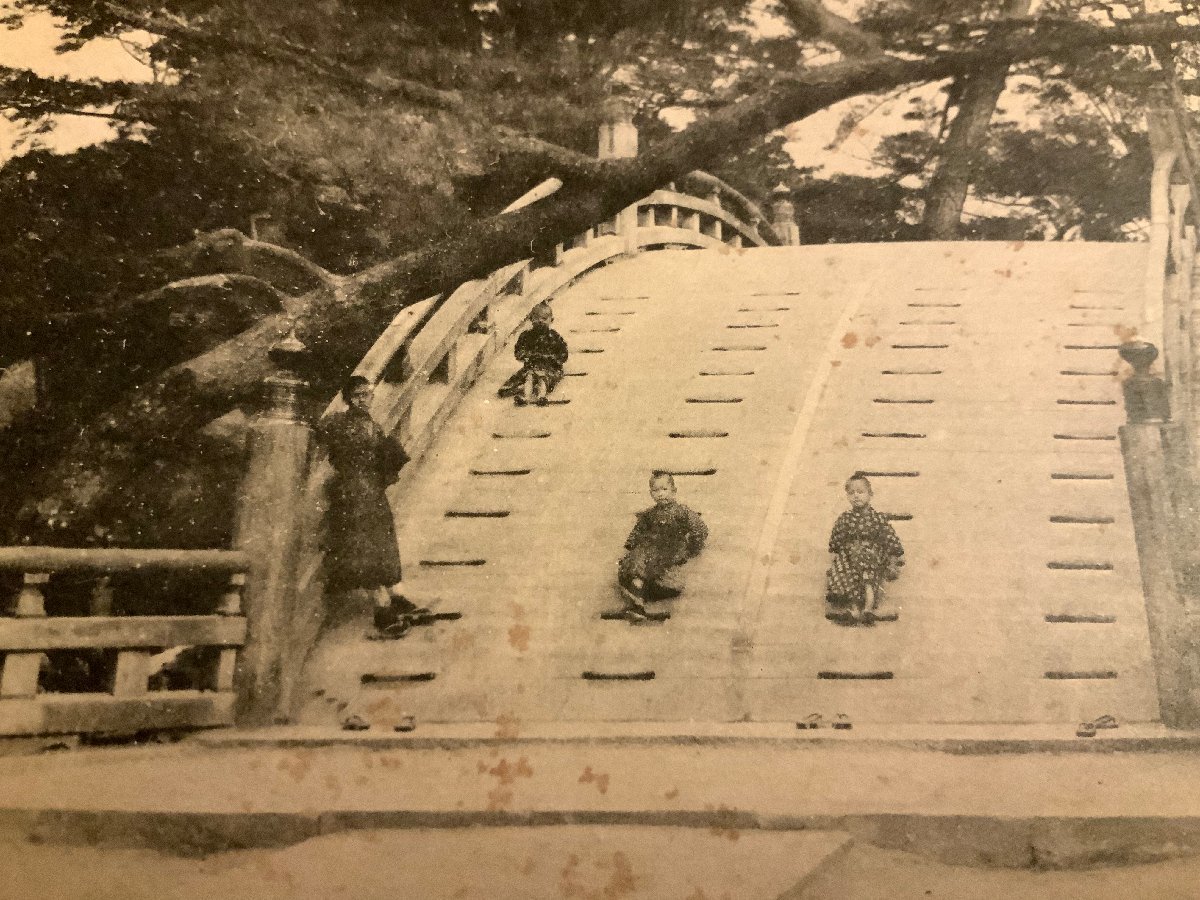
[299,237,1158,726]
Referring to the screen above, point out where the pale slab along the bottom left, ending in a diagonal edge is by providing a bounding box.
[0,826,850,900]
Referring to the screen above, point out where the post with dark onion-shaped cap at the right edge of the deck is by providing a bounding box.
[1120,341,1200,727]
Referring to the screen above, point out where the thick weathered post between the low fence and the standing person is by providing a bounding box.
[235,332,312,725]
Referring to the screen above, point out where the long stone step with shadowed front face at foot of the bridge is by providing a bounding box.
[7,725,1200,868]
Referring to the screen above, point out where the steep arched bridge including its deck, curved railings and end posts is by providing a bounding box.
[0,105,1200,734]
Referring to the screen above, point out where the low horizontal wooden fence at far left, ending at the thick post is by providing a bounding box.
[0,547,250,737]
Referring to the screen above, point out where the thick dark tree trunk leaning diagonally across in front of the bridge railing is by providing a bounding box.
[16,14,1200,540]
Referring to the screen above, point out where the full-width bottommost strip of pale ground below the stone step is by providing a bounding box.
[9,826,1200,900]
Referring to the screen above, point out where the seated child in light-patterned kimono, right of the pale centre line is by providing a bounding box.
[826,472,904,624]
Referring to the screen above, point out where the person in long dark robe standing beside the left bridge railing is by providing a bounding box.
[317,376,427,637]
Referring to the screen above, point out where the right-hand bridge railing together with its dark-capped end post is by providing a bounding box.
[1120,93,1200,727]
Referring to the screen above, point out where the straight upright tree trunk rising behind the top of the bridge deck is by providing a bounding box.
[922,0,1032,241]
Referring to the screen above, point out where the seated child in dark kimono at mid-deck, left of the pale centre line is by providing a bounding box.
[617,472,708,622]
